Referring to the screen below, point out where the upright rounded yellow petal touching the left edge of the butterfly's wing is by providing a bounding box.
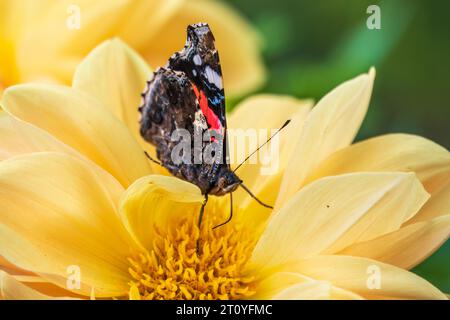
[73,39,151,145]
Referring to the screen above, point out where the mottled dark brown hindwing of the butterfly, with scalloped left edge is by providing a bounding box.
[139,68,212,193]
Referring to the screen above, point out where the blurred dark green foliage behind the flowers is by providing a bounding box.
[225,0,450,292]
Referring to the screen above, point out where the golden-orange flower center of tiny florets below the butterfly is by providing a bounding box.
[129,220,254,300]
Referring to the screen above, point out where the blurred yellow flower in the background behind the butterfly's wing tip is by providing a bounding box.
[0,0,265,95]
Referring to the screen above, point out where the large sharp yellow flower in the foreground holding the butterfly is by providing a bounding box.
[0,40,450,299]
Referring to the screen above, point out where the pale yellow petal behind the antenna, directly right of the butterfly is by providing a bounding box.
[228,94,312,187]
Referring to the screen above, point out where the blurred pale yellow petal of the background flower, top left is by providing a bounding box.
[17,0,133,84]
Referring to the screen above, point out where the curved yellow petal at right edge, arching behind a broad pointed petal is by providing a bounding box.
[307,134,450,194]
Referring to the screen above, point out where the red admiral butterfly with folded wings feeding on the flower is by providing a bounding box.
[139,23,288,232]
